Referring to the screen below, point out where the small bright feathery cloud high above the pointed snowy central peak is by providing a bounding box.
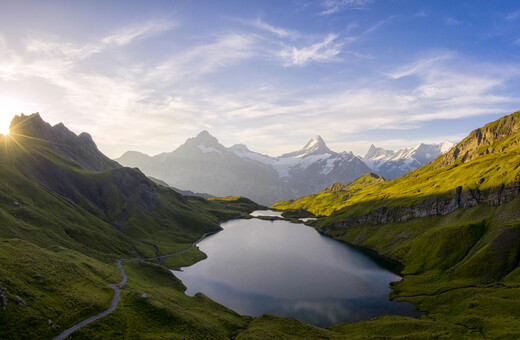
[281,34,343,66]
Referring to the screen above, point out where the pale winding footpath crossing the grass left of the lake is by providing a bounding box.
[53,226,225,340]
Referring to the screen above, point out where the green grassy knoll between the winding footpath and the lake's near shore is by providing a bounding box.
[71,262,249,339]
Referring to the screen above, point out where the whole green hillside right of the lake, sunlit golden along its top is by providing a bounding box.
[268,112,520,339]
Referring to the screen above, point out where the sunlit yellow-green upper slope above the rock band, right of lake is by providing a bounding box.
[273,111,520,218]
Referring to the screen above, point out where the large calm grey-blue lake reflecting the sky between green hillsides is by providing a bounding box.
[173,213,418,327]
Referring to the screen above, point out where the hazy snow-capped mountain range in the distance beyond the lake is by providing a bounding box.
[116,131,453,205]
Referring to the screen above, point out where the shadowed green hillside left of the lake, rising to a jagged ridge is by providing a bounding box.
[0,114,254,339]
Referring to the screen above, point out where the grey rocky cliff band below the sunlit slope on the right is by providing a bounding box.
[321,181,520,231]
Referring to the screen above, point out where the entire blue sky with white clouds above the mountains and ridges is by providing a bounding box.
[0,0,520,158]
